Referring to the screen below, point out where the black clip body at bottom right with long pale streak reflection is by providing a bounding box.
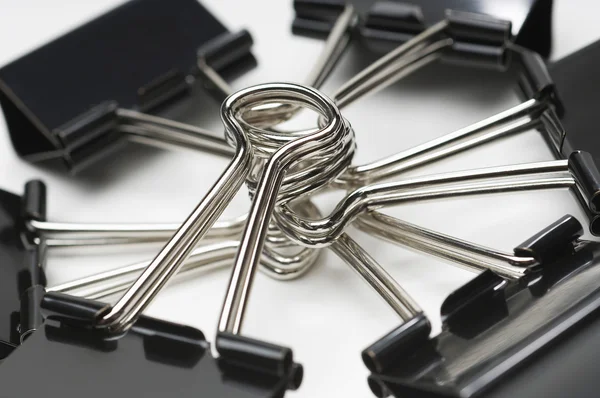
[369,216,600,398]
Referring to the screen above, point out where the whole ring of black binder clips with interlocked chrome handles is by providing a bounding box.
[0,0,600,397]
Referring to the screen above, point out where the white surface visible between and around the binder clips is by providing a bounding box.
[0,0,600,398]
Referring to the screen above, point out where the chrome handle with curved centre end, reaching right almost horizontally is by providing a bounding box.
[275,161,576,247]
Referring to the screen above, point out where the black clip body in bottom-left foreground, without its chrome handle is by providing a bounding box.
[0,293,292,398]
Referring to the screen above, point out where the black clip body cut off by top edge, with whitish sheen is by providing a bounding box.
[292,0,552,58]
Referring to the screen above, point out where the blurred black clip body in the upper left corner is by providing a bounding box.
[0,0,255,170]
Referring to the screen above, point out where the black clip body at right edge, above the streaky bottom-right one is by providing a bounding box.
[514,42,600,235]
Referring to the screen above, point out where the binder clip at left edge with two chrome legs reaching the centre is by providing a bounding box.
[0,180,319,360]
